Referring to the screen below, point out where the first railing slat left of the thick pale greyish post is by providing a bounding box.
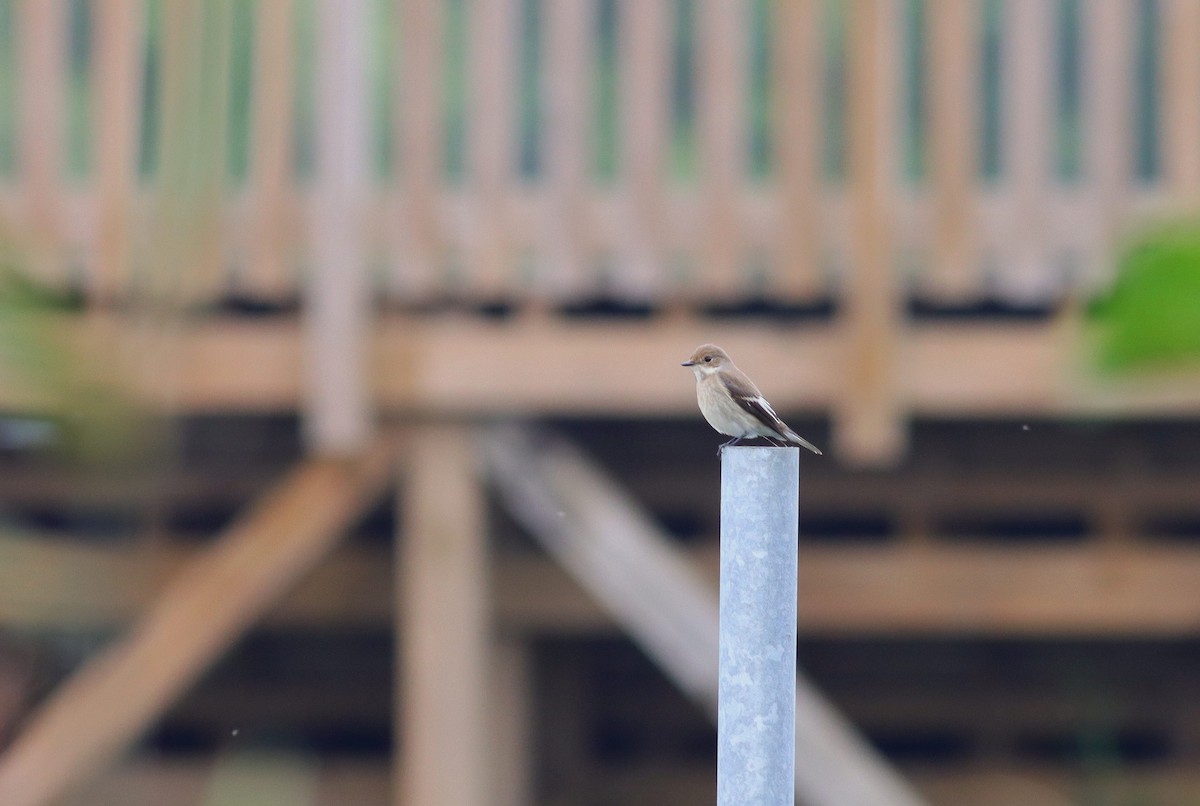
[238,0,299,300]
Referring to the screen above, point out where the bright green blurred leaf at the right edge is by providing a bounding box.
[1088,222,1200,372]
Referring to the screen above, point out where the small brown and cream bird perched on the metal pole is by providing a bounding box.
[682,344,821,456]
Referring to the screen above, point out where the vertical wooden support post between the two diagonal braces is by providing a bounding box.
[396,425,491,806]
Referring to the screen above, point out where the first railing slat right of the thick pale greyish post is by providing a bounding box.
[389,0,445,300]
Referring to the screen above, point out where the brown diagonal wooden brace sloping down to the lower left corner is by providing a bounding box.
[0,449,391,806]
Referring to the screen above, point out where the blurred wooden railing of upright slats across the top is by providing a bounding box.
[0,0,1200,305]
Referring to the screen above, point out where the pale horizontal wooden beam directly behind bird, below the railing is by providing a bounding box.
[9,314,1200,416]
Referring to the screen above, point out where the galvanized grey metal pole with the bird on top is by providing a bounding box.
[716,447,800,806]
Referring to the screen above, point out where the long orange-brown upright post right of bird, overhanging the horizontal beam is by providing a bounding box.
[836,0,904,462]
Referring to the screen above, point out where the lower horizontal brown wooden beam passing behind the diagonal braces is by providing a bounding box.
[11,540,1200,637]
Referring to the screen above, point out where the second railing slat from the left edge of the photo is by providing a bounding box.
[88,0,142,303]
